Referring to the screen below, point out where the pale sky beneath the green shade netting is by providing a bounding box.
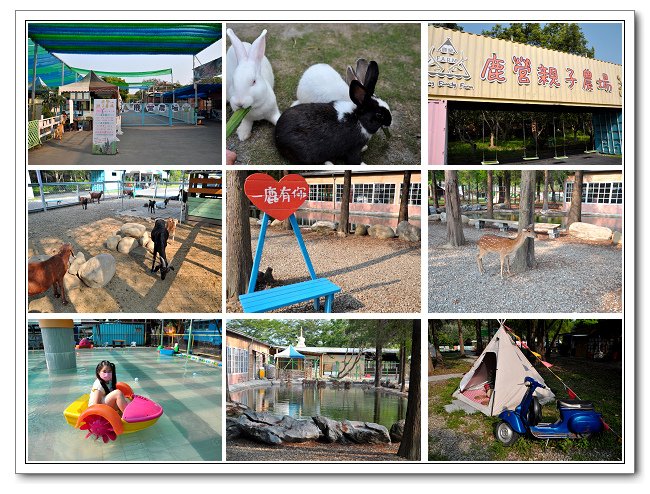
[55,39,223,89]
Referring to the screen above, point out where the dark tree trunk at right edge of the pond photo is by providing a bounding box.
[397,319,422,461]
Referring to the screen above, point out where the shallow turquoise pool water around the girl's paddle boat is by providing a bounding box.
[27,348,222,462]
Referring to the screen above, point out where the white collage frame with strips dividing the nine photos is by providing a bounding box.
[15,7,640,474]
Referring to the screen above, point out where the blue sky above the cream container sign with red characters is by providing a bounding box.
[459,22,623,64]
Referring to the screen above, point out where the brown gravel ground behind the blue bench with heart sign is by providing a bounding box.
[228,226,421,313]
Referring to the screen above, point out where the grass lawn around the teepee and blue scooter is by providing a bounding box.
[428,354,623,461]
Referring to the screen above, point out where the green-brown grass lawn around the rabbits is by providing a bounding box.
[227,23,421,166]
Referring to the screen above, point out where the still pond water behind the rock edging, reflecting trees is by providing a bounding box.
[230,386,408,429]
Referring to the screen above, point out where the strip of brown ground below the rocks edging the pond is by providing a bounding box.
[226,439,406,463]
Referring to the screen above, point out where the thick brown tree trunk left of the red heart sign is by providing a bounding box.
[226,170,253,299]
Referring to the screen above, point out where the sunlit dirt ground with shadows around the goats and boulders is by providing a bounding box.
[27,199,222,312]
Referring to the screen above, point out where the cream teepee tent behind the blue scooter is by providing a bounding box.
[454,326,555,416]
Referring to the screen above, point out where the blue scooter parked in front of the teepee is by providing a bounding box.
[495,377,605,446]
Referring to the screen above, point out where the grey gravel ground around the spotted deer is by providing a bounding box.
[429,221,623,313]
